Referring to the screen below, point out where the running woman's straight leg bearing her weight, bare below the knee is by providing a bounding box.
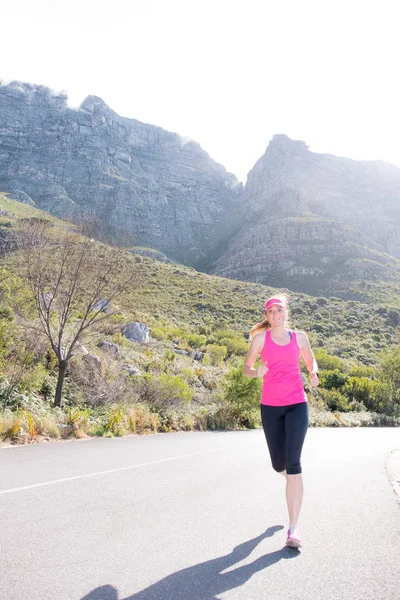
[285,402,308,527]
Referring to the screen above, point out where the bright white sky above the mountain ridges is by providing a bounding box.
[0,0,400,181]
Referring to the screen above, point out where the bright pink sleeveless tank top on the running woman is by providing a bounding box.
[260,329,307,406]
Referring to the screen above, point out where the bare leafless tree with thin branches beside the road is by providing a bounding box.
[19,220,127,406]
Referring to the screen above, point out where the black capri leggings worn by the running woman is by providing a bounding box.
[261,402,308,475]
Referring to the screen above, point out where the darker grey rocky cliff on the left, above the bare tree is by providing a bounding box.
[0,83,242,266]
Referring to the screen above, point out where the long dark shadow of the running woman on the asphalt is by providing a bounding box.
[81,525,300,600]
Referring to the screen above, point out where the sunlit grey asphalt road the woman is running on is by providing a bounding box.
[0,428,400,600]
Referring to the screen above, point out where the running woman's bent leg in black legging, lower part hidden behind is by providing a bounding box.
[261,404,285,475]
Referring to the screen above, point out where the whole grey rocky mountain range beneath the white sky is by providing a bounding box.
[0,82,400,299]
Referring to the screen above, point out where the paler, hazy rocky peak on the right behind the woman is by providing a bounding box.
[213,135,400,294]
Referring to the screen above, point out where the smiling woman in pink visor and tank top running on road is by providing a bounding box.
[243,294,319,548]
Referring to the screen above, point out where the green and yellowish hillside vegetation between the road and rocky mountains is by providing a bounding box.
[0,196,400,442]
